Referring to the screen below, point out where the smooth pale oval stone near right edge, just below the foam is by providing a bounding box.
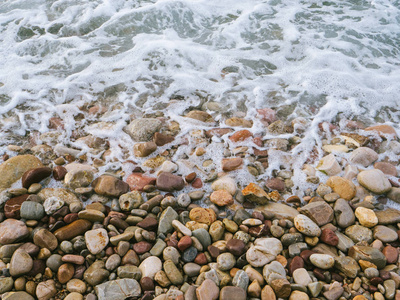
[357,169,392,194]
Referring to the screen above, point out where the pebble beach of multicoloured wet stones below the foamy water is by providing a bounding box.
[0,106,400,300]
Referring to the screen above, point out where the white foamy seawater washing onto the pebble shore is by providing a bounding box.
[0,0,400,199]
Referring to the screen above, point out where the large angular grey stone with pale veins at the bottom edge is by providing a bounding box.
[94,278,142,300]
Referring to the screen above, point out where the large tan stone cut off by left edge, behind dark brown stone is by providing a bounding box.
[0,155,43,190]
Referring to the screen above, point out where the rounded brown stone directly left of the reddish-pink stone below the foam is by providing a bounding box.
[92,175,129,197]
